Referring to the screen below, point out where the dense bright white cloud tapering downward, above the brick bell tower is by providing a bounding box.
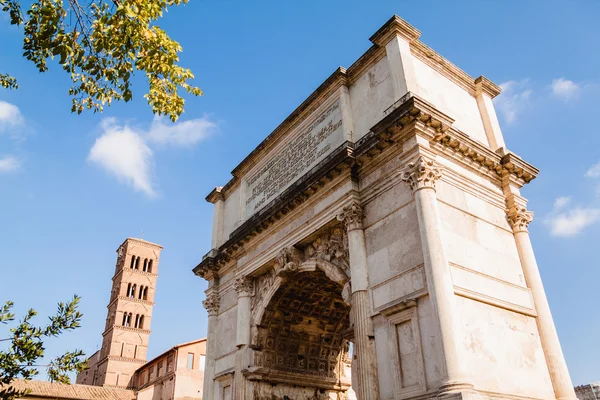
[88,119,156,197]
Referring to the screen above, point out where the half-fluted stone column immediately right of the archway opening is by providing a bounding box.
[337,202,379,400]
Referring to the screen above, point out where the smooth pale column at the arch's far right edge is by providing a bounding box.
[507,204,576,400]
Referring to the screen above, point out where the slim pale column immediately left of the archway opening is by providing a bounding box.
[233,276,254,400]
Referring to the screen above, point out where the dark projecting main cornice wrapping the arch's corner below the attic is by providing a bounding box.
[193,93,537,280]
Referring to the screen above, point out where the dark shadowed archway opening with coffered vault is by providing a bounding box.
[255,268,350,393]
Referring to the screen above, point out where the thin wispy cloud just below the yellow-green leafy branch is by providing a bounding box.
[148,116,217,146]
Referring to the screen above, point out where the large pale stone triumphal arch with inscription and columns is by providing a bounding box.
[194,16,575,400]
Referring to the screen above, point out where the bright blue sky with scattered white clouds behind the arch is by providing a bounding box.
[0,0,600,384]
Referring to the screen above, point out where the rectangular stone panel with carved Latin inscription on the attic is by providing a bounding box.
[245,99,344,217]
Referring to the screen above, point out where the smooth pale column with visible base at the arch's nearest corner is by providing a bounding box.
[402,156,472,394]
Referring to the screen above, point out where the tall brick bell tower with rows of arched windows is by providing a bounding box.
[89,238,162,387]
